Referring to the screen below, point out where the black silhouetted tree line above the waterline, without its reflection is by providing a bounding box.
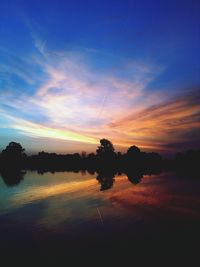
[0,139,200,172]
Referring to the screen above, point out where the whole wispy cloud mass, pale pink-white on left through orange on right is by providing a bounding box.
[0,39,200,154]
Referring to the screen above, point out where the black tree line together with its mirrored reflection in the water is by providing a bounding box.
[0,139,200,190]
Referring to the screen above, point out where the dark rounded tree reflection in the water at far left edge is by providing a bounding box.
[1,169,26,186]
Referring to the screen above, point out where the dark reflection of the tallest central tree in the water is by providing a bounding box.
[96,170,115,191]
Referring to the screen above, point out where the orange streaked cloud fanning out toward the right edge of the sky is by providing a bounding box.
[109,89,200,151]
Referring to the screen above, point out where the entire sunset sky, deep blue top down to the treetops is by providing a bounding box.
[0,0,200,154]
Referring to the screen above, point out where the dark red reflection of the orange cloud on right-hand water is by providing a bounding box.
[106,173,200,220]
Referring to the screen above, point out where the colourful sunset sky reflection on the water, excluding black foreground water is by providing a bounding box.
[0,172,200,232]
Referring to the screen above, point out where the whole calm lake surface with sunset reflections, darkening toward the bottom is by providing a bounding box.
[0,172,200,261]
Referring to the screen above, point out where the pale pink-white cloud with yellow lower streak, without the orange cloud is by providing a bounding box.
[0,42,162,151]
